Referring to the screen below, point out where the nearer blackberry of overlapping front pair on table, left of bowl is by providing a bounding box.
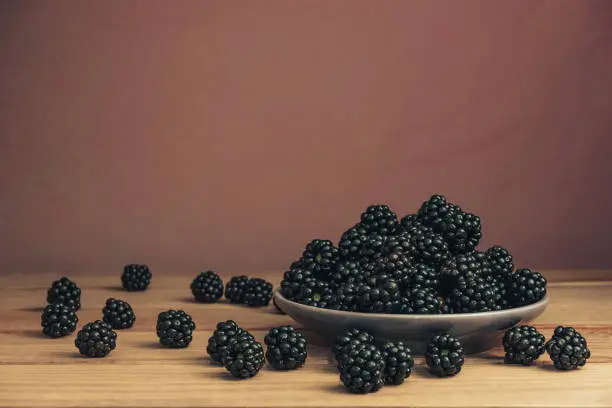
[225,337,265,379]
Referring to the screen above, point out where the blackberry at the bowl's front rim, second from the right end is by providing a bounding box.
[447,276,497,313]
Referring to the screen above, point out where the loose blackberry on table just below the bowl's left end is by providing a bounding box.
[264,326,308,370]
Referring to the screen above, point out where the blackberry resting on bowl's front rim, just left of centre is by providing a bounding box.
[355,276,400,313]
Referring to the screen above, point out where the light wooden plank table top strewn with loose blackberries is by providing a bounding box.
[0,271,612,407]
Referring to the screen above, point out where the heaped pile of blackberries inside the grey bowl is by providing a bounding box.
[280,195,546,314]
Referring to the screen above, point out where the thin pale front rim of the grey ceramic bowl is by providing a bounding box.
[274,288,549,321]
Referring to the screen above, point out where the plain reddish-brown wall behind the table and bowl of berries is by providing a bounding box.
[0,0,612,273]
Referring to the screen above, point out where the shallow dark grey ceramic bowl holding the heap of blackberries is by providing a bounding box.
[274,290,548,354]
